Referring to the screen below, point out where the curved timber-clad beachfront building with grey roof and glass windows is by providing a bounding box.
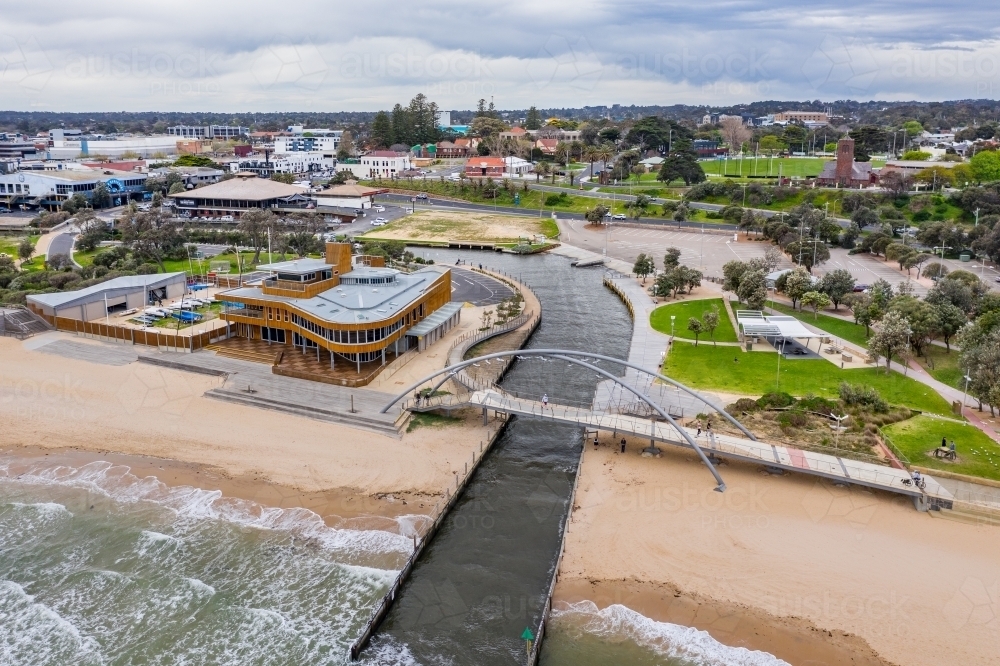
[216,243,462,377]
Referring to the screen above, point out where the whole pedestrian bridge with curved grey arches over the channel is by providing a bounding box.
[382,349,954,508]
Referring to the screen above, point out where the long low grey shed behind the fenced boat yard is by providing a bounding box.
[27,272,187,324]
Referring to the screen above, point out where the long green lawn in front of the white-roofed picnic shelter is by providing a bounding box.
[664,344,951,415]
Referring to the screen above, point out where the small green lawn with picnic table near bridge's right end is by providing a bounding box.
[882,416,1000,481]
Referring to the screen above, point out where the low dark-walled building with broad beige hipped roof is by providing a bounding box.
[166,174,316,220]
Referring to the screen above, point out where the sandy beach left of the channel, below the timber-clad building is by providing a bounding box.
[0,338,486,524]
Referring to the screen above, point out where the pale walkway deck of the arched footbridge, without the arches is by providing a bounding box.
[464,390,954,502]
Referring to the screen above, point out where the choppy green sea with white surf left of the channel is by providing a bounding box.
[0,460,419,666]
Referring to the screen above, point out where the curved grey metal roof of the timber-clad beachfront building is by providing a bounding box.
[225,266,450,324]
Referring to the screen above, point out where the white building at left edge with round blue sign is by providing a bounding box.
[0,167,149,210]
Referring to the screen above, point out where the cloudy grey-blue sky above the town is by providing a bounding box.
[0,0,1000,112]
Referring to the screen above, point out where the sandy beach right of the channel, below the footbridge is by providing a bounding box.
[555,438,1000,666]
